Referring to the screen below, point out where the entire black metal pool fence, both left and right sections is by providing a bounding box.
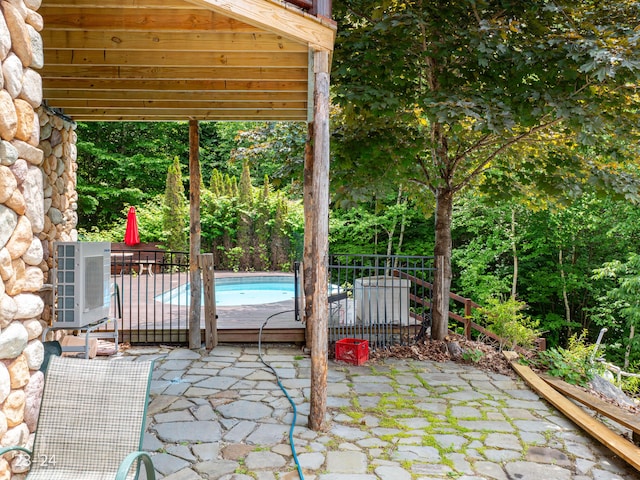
[111,249,434,348]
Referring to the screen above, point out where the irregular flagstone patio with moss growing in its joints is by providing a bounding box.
[102,345,640,480]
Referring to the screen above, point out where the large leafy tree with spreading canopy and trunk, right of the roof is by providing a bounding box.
[333,0,640,339]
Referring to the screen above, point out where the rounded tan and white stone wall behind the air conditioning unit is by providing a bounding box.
[0,0,76,480]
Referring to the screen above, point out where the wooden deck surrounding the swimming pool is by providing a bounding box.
[112,272,305,343]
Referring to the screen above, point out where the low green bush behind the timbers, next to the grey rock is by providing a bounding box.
[537,331,598,387]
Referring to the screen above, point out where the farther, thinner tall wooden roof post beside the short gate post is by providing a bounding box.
[189,120,202,349]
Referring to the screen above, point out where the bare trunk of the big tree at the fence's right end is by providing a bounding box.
[431,188,453,340]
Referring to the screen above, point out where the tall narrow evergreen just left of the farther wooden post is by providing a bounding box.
[162,157,188,251]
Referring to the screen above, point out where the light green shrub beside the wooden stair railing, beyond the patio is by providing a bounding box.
[473,298,540,350]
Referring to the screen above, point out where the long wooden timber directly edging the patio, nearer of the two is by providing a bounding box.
[503,352,640,471]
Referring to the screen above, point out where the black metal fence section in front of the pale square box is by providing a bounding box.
[329,254,435,348]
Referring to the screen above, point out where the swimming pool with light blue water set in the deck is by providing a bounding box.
[155,276,295,307]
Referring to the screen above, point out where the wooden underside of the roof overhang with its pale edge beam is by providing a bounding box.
[39,0,335,121]
